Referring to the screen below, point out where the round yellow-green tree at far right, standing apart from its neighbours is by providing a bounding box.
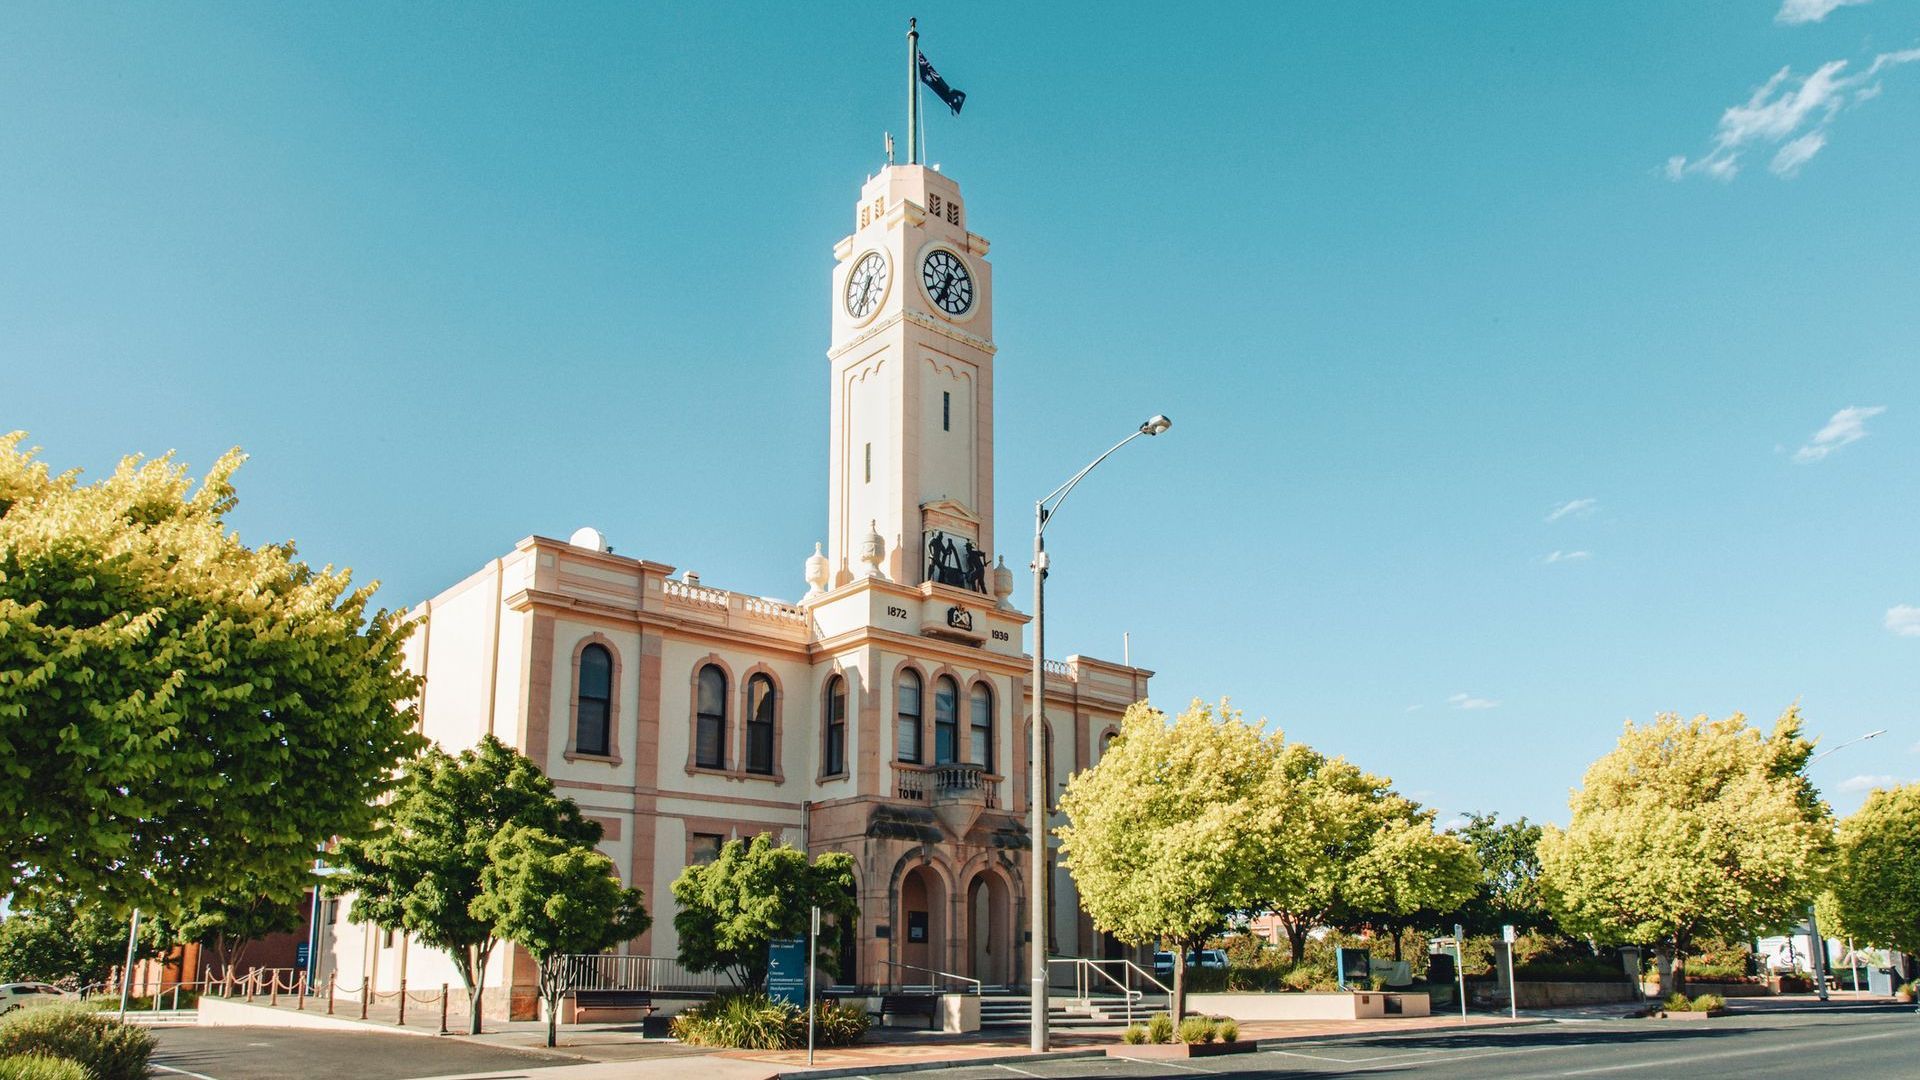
[1540,709,1834,994]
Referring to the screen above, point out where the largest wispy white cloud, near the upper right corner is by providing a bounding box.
[1667,49,1920,181]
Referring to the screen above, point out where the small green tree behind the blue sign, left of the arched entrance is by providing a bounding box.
[672,832,860,990]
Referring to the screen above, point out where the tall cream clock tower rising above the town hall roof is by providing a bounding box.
[828,165,995,592]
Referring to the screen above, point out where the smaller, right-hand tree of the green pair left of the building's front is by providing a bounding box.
[474,826,653,1045]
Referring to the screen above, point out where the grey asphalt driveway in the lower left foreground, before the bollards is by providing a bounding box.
[152,1026,566,1080]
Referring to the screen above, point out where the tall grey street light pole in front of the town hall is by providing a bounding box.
[1027,407,1173,1053]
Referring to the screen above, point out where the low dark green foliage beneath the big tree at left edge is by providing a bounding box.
[0,896,165,988]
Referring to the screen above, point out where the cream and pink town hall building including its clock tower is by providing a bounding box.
[317,155,1152,1015]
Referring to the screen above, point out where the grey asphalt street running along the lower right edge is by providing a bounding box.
[914,1005,1920,1080]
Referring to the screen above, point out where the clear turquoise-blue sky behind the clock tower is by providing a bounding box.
[0,0,1920,821]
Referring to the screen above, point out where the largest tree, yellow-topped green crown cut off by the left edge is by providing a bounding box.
[0,432,420,917]
